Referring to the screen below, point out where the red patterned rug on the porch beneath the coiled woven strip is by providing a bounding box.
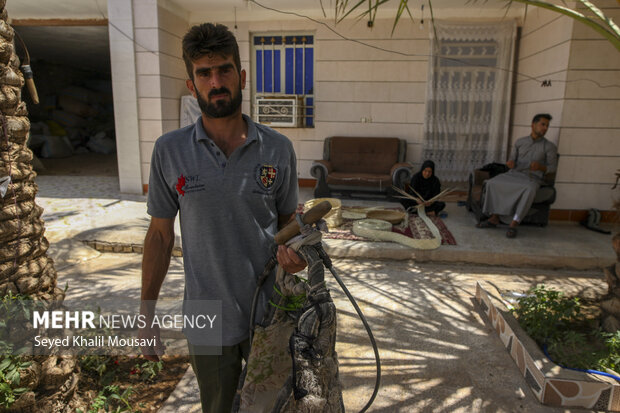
[297,204,456,245]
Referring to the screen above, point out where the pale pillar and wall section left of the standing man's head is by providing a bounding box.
[108,0,188,193]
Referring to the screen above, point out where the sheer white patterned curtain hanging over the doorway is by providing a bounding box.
[421,21,516,182]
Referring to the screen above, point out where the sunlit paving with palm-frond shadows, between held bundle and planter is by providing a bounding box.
[328,260,599,412]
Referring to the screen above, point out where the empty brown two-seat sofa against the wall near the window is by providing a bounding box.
[310,136,411,198]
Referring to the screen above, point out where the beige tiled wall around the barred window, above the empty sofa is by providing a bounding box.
[213,19,429,178]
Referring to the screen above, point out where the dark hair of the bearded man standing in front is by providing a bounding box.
[183,23,241,80]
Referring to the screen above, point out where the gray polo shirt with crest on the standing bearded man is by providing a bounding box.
[147,115,298,346]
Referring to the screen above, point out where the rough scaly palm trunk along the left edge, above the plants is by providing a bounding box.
[0,0,64,301]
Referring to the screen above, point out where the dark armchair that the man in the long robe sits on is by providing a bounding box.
[467,169,556,227]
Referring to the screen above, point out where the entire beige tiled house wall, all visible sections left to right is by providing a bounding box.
[109,0,620,210]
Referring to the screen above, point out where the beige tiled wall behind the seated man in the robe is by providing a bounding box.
[511,1,620,210]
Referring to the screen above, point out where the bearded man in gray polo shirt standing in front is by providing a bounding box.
[139,23,306,413]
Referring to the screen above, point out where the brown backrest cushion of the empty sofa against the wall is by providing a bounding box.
[328,136,400,173]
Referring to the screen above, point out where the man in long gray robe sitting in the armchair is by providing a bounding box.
[477,113,558,238]
